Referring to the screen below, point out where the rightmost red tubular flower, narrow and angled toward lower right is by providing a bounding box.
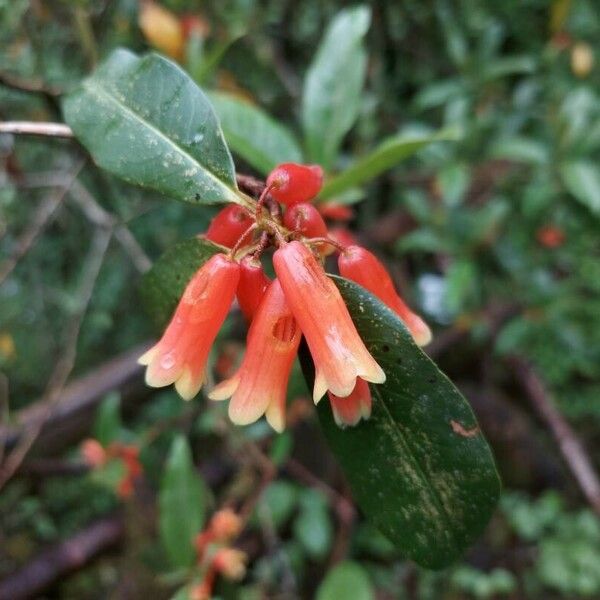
[338,246,431,346]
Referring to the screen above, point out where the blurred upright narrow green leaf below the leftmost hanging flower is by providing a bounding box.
[158,435,206,567]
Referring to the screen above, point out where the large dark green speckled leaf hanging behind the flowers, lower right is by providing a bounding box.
[303,277,500,568]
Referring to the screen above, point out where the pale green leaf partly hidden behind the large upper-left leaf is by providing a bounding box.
[210,92,302,175]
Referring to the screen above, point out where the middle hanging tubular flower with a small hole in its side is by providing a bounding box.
[208,280,301,431]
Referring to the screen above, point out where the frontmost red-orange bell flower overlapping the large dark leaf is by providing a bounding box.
[273,242,385,402]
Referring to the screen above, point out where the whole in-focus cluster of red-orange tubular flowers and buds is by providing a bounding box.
[139,163,431,431]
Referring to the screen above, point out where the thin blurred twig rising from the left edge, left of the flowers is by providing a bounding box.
[0,229,112,489]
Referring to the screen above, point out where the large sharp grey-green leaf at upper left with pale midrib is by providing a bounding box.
[63,49,247,209]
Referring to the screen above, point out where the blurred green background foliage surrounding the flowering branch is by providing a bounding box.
[0,0,600,599]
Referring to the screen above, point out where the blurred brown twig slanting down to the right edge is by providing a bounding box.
[509,357,600,515]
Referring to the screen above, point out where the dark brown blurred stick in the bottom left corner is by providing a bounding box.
[0,517,125,600]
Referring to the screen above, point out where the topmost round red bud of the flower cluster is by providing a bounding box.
[267,163,323,206]
